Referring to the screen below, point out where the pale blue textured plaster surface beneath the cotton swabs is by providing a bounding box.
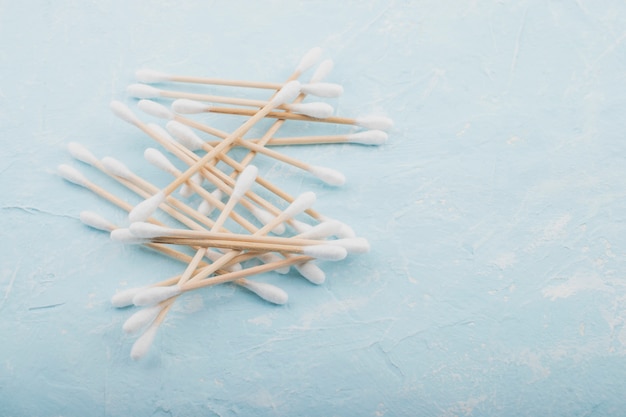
[0,0,626,417]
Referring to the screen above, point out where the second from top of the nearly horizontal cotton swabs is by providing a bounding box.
[126,84,335,119]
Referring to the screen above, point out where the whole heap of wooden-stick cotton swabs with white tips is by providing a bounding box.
[58,48,392,359]
